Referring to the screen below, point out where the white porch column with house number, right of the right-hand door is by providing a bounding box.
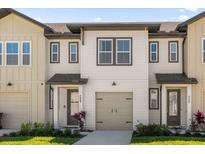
[186,85,192,128]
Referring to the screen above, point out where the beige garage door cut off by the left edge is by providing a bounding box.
[0,93,28,128]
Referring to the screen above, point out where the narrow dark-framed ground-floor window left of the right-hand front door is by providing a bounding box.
[149,88,159,110]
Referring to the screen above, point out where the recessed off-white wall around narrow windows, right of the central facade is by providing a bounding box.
[148,38,183,124]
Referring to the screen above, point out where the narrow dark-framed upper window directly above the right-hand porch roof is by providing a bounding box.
[169,41,178,63]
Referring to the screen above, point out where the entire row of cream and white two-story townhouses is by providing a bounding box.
[0,9,205,130]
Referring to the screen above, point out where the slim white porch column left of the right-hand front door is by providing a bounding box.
[161,85,167,125]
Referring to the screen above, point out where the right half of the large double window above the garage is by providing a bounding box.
[116,39,131,64]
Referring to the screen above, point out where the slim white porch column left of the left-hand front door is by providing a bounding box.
[53,86,59,129]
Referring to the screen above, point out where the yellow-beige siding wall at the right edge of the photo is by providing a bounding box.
[185,17,205,112]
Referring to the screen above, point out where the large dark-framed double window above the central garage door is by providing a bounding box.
[97,38,132,65]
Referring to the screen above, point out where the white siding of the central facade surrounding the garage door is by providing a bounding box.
[81,30,149,129]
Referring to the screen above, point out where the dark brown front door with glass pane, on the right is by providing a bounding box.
[167,89,180,126]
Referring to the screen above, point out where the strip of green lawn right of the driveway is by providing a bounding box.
[131,136,205,145]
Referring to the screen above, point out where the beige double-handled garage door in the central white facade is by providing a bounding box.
[96,92,133,130]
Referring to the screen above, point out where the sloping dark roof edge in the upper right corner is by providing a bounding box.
[177,11,205,31]
